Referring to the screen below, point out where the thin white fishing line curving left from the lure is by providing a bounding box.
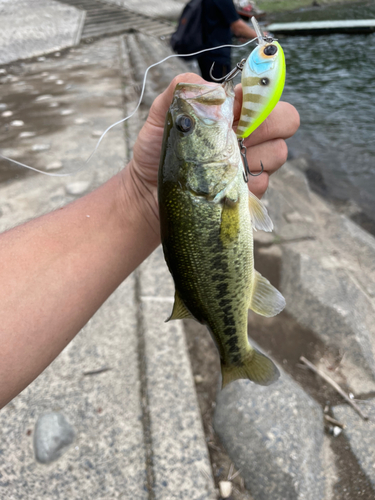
[0,37,259,177]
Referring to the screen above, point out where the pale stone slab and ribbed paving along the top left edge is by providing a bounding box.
[0,0,186,64]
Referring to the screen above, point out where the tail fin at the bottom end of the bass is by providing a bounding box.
[221,347,280,389]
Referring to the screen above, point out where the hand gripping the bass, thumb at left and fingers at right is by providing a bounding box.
[125,73,299,226]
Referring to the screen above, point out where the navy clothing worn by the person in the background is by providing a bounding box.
[202,0,240,66]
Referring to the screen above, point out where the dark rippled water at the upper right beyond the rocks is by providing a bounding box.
[233,2,375,232]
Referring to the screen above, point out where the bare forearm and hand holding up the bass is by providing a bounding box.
[0,74,296,407]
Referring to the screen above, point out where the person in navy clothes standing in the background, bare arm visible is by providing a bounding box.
[198,0,256,82]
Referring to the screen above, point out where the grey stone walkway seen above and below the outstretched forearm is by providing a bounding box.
[0,26,216,500]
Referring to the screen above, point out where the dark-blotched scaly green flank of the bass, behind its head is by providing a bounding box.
[165,171,253,363]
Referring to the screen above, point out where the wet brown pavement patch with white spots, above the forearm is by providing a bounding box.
[0,41,126,186]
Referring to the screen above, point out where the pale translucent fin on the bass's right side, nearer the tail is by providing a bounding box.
[249,271,285,317]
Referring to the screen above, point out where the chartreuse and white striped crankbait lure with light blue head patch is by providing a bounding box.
[236,18,285,139]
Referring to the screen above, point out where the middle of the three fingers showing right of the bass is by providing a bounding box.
[246,139,288,174]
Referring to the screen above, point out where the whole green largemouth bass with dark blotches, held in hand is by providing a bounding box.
[158,82,285,387]
